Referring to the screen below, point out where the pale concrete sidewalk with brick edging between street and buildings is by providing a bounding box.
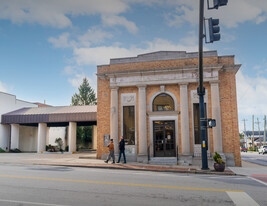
[0,152,235,175]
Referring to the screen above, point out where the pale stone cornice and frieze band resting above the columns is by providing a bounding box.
[97,64,241,87]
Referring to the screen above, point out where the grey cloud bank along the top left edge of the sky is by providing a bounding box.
[0,0,136,32]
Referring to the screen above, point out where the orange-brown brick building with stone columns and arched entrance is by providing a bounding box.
[97,51,241,166]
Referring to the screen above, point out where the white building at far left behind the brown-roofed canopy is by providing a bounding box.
[0,92,69,152]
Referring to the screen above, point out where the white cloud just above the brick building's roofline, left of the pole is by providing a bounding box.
[61,32,198,90]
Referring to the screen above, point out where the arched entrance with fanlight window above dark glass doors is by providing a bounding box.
[149,91,178,157]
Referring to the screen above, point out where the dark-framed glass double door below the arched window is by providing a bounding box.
[153,121,176,157]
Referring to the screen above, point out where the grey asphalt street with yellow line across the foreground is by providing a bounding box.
[0,163,267,206]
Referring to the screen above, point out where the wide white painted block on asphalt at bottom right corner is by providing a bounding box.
[226,192,260,206]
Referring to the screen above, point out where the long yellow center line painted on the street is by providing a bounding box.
[0,175,244,192]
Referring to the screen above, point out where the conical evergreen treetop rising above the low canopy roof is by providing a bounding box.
[71,78,97,106]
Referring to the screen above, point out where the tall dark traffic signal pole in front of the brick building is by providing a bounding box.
[198,0,209,170]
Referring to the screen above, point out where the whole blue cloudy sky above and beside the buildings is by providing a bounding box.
[0,0,267,131]
